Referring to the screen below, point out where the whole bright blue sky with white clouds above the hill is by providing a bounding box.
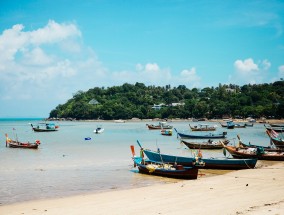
[0,0,284,118]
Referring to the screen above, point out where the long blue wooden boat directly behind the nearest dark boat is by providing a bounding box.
[137,141,257,170]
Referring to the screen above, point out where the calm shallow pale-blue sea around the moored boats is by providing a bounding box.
[0,118,270,205]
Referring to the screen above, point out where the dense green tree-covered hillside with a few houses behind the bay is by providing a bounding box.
[49,80,284,120]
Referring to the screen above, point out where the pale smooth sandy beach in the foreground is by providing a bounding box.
[0,161,284,215]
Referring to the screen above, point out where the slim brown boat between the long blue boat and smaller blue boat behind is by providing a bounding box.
[181,139,230,149]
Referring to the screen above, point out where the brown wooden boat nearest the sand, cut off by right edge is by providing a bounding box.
[223,144,284,161]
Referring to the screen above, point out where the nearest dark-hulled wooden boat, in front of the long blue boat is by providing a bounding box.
[132,157,198,179]
